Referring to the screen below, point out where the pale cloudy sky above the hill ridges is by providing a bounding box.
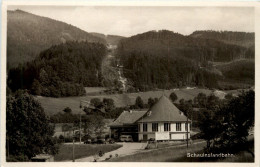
[8,6,254,37]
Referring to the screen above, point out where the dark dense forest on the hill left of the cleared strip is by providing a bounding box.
[7,42,107,97]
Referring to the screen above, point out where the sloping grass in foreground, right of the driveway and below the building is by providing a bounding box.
[106,142,206,162]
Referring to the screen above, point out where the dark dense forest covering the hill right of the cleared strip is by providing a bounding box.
[117,30,254,91]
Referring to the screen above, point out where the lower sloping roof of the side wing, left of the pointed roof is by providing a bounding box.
[109,109,147,126]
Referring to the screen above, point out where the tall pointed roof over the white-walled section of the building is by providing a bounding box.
[138,96,190,122]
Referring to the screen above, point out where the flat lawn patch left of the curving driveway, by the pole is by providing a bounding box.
[54,144,122,161]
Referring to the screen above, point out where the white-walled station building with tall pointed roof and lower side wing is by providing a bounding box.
[110,96,191,141]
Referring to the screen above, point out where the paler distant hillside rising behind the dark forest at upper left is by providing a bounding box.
[7,10,106,69]
